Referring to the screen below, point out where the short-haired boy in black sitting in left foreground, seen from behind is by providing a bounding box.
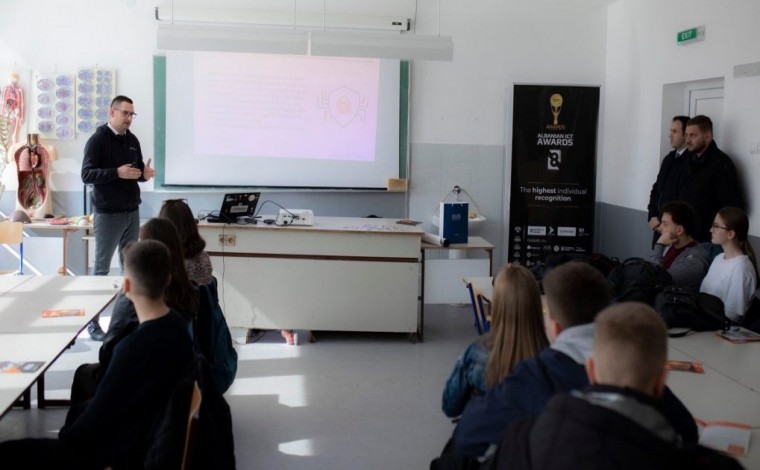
[0,240,194,469]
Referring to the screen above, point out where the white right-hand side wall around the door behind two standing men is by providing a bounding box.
[599,0,760,235]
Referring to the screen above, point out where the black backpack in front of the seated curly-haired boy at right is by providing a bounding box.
[607,258,673,305]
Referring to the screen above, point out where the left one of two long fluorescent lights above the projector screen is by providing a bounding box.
[157,25,309,55]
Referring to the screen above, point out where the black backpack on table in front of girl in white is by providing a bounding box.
[654,286,730,331]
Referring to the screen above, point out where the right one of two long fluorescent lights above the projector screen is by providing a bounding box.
[311,31,454,61]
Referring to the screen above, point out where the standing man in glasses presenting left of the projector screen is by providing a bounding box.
[82,95,156,341]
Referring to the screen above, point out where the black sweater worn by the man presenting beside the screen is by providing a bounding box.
[82,124,145,214]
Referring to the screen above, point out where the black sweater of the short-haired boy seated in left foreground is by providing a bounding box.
[59,311,193,468]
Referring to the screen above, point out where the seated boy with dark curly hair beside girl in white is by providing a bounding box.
[649,201,710,292]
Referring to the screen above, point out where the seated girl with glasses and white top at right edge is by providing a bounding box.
[699,207,758,323]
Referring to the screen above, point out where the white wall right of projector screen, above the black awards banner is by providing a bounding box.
[411,0,606,145]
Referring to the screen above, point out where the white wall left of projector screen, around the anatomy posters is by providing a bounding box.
[0,0,156,191]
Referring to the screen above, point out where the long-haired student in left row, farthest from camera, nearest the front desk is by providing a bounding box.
[158,199,214,286]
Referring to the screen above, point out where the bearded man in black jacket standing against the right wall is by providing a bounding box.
[677,115,745,242]
